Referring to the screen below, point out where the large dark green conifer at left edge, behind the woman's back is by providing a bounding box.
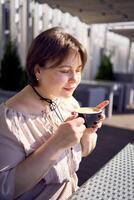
[0,41,27,91]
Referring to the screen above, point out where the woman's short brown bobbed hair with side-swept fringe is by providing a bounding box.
[26,27,87,86]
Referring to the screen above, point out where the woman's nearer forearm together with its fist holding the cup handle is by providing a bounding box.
[15,115,85,197]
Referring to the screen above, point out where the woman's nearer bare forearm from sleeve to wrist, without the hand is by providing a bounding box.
[15,130,64,197]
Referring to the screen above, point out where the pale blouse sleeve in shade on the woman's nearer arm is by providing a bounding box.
[0,106,25,200]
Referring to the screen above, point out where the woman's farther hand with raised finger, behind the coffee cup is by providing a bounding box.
[81,100,109,157]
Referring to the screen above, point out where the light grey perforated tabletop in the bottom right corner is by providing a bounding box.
[69,144,134,200]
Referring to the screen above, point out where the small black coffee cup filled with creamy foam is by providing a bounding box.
[76,107,102,128]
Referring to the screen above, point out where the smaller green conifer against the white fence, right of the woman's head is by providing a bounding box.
[96,54,114,81]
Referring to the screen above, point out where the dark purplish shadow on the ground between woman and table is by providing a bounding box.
[77,125,134,186]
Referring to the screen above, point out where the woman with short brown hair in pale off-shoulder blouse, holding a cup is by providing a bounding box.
[0,27,108,200]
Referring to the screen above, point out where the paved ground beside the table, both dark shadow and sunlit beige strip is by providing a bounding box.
[77,112,134,185]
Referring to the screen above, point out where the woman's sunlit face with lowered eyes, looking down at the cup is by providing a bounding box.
[36,50,82,98]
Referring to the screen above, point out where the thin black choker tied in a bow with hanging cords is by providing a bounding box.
[31,85,64,122]
